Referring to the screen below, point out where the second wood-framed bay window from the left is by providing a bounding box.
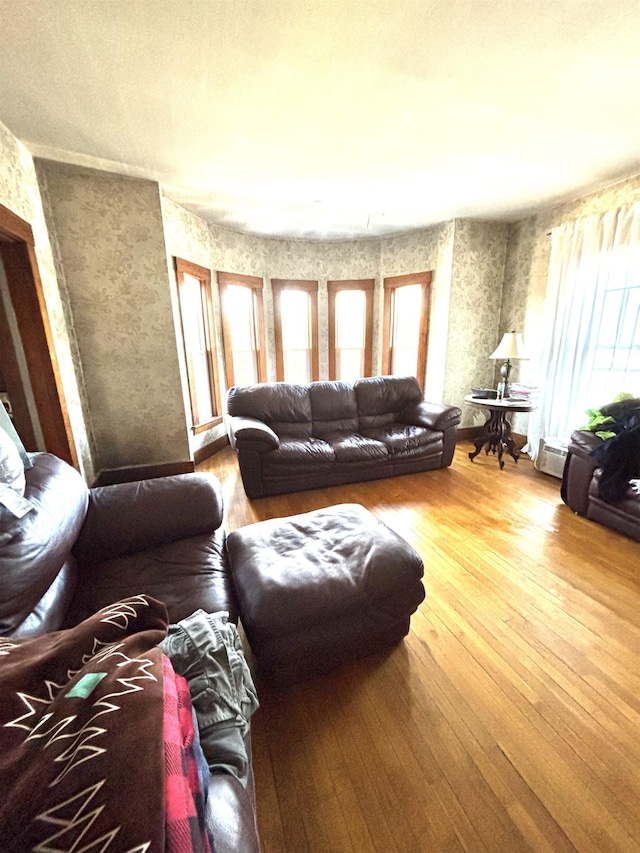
[218,272,267,388]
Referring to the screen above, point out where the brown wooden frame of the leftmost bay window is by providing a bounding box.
[175,258,223,434]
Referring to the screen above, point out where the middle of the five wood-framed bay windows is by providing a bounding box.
[271,279,319,384]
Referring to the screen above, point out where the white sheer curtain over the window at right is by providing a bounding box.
[527,202,640,459]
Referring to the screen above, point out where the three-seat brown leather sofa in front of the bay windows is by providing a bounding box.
[228,376,461,498]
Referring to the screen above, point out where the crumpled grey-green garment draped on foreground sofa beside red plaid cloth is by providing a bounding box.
[160,610,259,787]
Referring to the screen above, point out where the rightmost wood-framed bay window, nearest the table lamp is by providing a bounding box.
[382,272,431,385]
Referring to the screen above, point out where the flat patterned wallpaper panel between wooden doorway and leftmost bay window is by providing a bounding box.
[38,165,190,470]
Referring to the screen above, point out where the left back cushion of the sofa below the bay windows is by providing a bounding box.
[227,382,312,438]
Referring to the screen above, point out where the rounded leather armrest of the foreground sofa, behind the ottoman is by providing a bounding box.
[73,473,224,564]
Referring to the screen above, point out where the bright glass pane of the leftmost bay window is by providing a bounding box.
[180,273,214,423]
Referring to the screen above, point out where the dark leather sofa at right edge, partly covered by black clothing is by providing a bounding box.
[561,430,640,541]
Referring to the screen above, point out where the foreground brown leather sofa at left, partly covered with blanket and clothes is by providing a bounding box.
[0,453,259,853]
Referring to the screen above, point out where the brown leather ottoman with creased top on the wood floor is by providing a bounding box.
[227,504,424,684]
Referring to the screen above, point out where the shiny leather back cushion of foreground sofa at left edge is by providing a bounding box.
[0,453,88,636]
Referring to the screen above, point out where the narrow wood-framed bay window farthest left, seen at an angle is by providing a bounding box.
[175,258,222,433]
